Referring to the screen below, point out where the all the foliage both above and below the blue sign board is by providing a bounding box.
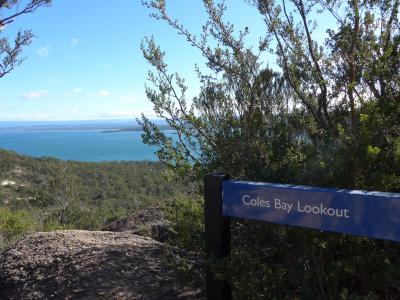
[141,0,400,299]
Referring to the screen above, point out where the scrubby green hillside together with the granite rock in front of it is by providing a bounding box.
[0,150,201,299]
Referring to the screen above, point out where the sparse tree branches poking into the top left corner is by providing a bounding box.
[0,0,51,78]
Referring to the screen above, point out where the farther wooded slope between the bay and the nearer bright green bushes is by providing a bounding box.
[0,149,184,206]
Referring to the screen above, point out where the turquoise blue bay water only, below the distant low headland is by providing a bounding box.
[0,130,164,162]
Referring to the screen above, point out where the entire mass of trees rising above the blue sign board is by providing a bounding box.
[141,0,400,191]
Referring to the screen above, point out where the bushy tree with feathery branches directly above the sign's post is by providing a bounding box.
[141,1,295,184]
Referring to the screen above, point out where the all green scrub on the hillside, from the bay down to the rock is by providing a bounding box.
[0,150,187,247]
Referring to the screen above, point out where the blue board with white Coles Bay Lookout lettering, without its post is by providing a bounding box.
[222,180,400,241]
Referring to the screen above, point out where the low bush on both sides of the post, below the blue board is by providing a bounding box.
[165,197,400,299]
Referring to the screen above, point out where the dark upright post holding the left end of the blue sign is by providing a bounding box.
[204,174,232,300]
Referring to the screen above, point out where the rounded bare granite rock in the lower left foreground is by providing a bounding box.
[0,230,201,300]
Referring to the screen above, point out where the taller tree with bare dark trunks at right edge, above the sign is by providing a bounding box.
[249,0,400,191]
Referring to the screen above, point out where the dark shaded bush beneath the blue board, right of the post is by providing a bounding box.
[225,220,400,299]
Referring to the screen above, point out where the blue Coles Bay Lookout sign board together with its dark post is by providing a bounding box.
[204,174,400,300]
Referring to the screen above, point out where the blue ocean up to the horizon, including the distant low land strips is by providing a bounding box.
[0,121,169,162]
